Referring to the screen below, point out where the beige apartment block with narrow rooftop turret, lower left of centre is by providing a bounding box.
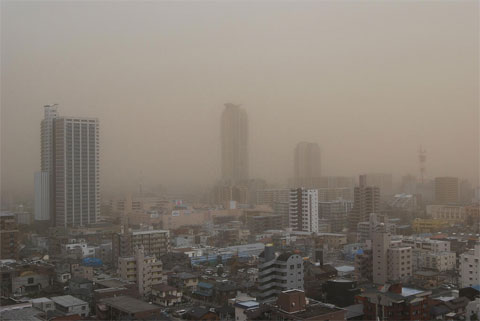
[118,247,163,296]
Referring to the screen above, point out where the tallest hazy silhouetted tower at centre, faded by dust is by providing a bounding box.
[221,103,248,185]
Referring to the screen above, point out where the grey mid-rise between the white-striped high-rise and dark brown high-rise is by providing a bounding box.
[318,199,353,232]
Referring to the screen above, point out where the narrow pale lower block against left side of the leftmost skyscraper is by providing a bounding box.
[34,171,51,222]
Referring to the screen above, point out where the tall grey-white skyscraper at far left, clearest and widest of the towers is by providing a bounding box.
[35,104,100,227]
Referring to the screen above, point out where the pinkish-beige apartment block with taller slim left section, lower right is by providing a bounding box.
[372,224,413,284]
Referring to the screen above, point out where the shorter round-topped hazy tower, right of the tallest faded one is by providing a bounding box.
[293,142,320,188]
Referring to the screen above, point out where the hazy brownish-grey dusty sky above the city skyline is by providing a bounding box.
[1,1,479,196]
